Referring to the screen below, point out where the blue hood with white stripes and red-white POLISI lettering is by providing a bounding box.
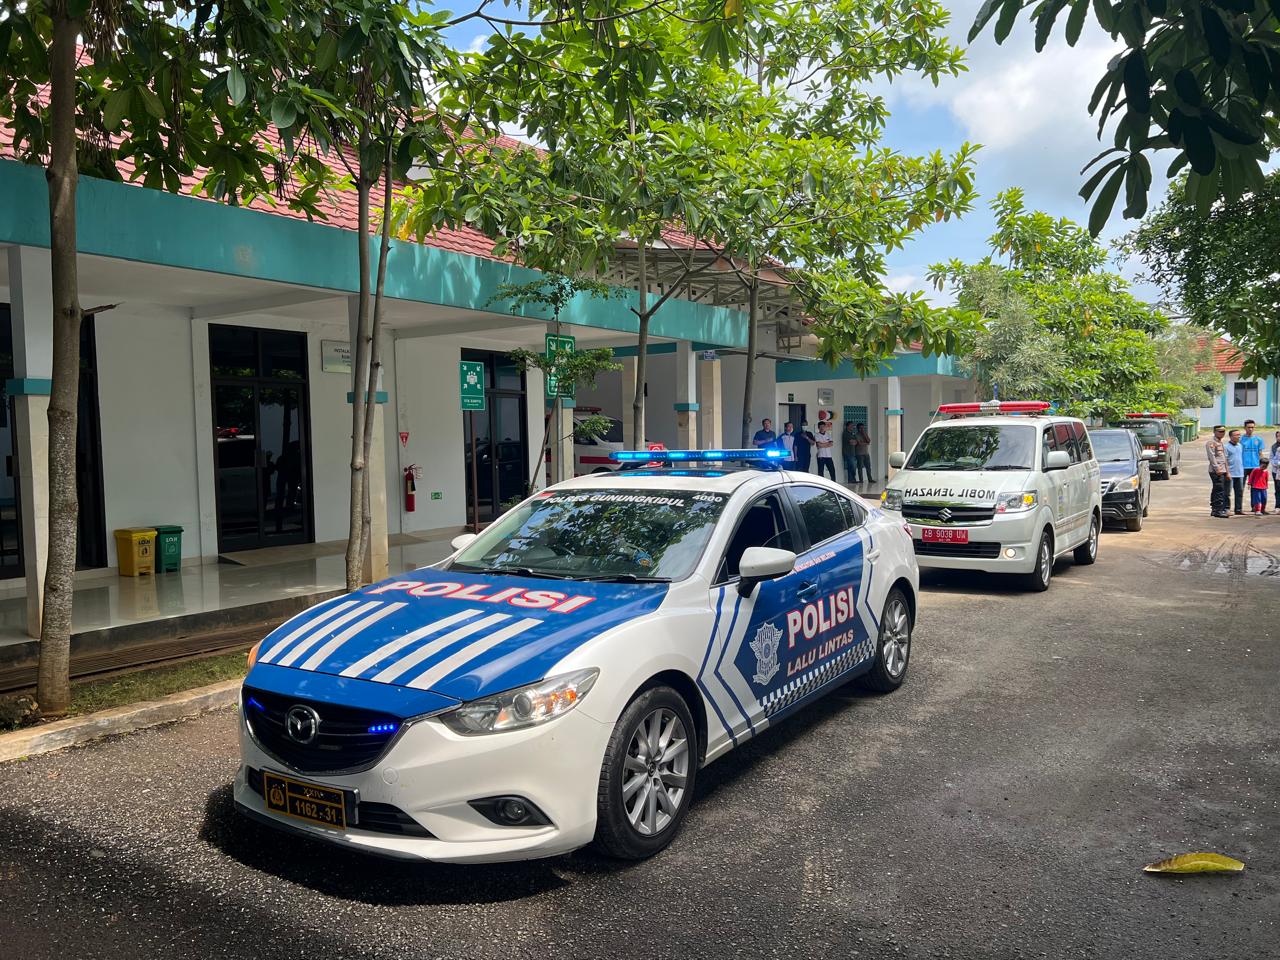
[246,570,667,700]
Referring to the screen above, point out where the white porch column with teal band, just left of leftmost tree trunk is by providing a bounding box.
[8,247,54,637]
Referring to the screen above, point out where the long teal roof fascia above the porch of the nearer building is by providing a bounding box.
[0,160,746,347]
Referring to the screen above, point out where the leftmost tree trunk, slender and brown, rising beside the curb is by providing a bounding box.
[36,4,81,717]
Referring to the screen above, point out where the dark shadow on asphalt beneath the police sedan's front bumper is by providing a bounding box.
[200,783,566,906]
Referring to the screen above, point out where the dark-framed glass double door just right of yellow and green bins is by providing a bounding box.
[209,325,312,552]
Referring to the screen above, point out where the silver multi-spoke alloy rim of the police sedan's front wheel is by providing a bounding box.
[622,707,689,837]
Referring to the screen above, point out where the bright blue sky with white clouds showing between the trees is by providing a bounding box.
[453,0,1167,302]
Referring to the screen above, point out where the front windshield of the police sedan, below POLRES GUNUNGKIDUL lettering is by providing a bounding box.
[451,489,728,581]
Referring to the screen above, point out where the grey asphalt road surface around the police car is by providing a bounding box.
[0,452,1280,960]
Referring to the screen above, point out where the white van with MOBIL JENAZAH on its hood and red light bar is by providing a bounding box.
[881,401,1102,590]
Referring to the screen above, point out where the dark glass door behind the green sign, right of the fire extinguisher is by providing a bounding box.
[462,349,529,525]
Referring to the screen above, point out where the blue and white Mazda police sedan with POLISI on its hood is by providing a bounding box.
[234,451,918,863]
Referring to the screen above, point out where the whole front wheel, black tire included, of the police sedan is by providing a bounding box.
[595,686,699,860]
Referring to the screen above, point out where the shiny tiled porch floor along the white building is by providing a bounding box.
[0,540,449,645]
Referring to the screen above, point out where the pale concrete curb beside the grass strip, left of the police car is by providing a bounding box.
[0,680,243,763]
